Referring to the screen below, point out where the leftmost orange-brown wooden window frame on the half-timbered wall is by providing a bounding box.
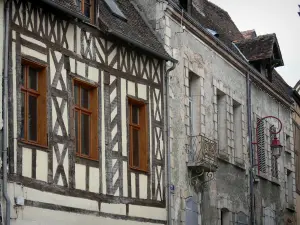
[20,59,48,148]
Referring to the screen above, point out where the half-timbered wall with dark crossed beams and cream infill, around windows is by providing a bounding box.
[9,0,165,223]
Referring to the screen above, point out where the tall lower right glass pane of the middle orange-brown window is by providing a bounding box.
[81,114,90,155]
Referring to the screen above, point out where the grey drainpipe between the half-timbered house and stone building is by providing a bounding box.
[165,62,176,225]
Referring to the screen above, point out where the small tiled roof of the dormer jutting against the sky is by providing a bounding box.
[235,34,276,61]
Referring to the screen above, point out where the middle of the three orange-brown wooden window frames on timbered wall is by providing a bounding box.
[72,78,99,161]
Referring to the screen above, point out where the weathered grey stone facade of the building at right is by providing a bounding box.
[136,0,295,225]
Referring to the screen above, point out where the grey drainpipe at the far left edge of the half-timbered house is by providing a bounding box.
[2,1,10,225]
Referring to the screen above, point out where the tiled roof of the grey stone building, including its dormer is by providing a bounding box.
[173,0,291,102]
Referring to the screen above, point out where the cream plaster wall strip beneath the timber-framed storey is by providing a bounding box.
[8,183,166,225]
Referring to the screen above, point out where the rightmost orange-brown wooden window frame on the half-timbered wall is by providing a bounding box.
[128,98,149,173]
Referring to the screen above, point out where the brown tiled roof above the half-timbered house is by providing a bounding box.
[43,0,172,60]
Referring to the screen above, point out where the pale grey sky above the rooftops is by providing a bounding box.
[210,0,300,87]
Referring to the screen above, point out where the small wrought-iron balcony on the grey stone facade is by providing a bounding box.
[187,135,218,172]
